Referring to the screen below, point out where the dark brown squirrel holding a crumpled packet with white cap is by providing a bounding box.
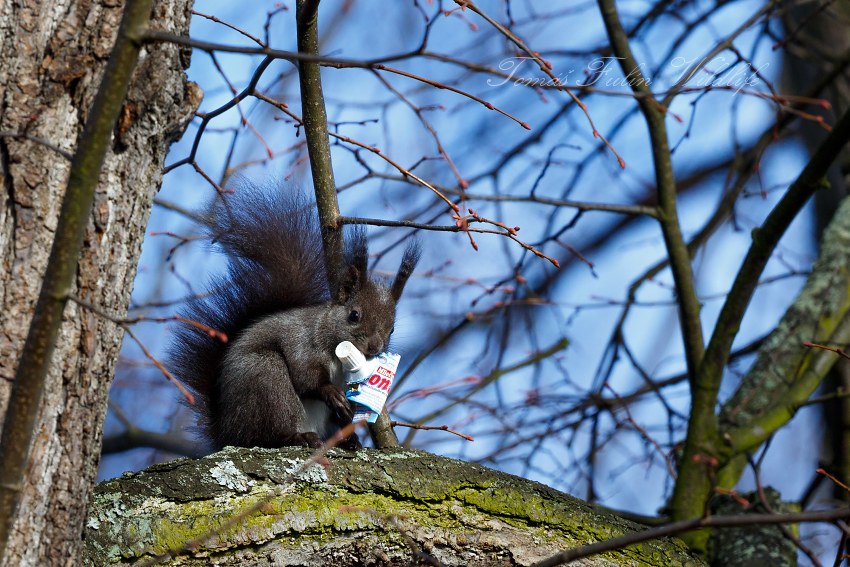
[169,187,419,448]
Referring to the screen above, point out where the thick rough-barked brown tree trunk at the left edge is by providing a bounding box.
[0,0,200,565]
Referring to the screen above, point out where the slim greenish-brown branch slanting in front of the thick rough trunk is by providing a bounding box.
[0,0,153,558]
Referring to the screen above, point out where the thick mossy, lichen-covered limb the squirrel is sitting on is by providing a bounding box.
[84,447,703,567]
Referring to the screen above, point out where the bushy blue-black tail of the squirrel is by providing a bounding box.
[168,185,330,442]
